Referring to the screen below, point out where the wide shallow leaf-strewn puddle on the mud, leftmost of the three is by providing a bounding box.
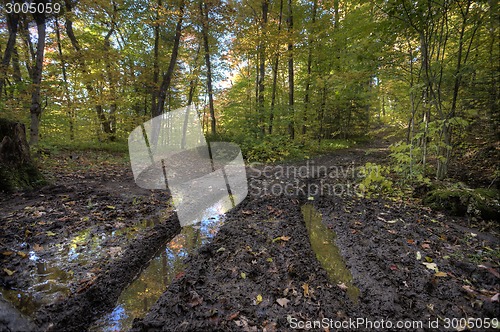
[0,217,159,316]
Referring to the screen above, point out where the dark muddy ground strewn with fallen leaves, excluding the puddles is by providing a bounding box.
[0,141,500,331]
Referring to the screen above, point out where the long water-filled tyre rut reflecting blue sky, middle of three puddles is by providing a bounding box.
[89,202,228,332]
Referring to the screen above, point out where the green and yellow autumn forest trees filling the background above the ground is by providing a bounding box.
[0,0,500,178]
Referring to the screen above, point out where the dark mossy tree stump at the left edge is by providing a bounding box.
[0,118,44,192]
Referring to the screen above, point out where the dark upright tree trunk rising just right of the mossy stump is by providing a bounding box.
[30,8,46,145]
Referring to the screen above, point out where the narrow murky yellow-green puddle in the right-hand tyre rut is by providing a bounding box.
[302,204,359,303]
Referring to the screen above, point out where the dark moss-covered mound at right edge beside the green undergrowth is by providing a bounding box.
[423,183,500,220]
